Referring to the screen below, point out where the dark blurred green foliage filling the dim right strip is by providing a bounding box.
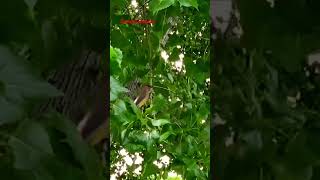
[212,0,320,180]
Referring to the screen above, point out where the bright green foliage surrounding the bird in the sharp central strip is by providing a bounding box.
[110,0,210,179]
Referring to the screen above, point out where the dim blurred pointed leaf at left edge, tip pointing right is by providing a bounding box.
[0,46,62,125]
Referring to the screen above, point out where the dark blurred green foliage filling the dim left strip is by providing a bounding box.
[0,0,107,180]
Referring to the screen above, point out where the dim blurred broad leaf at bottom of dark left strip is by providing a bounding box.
[8,119,84,180]
